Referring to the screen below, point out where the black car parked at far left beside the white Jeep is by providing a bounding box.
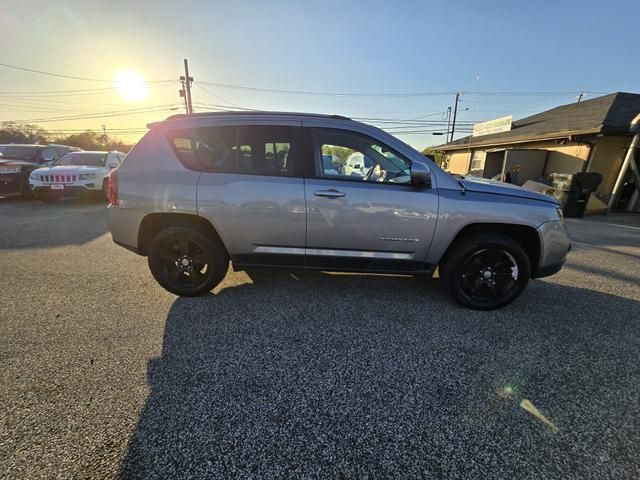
[0,143,81,197]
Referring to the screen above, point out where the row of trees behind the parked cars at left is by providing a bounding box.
[0,122,133,153]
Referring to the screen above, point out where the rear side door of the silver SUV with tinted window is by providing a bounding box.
[191,122,306,266]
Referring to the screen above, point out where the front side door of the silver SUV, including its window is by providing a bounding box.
[305,128,438,272]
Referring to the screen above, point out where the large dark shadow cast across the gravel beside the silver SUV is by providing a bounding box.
[121,273,640,478]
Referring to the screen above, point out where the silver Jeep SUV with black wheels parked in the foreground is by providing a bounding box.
[109,112,570,309]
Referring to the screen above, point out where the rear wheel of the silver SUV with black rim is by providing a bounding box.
[147,226,229,297]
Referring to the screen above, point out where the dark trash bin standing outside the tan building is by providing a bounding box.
[551,172,602,218]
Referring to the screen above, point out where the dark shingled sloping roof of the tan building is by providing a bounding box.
[435,92,640,150]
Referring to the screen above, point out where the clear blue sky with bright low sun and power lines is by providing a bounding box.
[0,0,640,148]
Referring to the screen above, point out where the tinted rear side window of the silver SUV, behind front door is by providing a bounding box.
[169,126,296,177]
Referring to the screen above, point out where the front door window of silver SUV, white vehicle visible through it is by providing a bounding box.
[314,129,411,184]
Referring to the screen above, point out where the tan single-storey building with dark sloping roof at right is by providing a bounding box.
[436,92,640,213]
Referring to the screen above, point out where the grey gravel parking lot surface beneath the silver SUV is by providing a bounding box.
[0,200,640,479]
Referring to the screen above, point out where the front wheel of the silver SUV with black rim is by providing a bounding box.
[440,233,531,310]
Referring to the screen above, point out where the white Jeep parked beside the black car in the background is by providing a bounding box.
[29,151,125,203]
